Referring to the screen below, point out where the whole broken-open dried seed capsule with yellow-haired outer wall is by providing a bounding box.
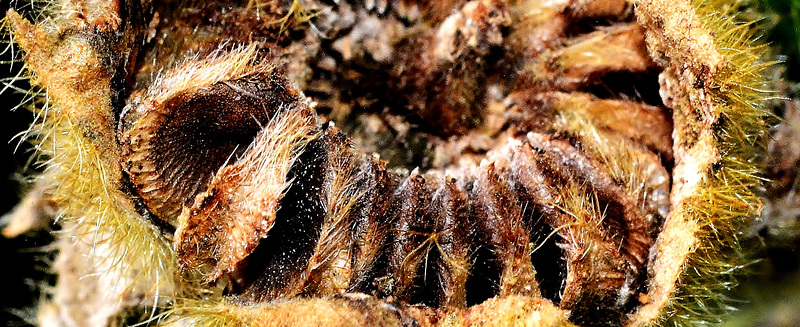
[0,0,788,326]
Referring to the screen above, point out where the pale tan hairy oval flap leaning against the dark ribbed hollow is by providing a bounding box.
[175,103,318,281]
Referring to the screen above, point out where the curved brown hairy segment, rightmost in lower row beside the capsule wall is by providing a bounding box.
[511,135,650,325]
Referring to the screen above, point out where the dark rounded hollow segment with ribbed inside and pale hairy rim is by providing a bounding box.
[120,48,299,225]
